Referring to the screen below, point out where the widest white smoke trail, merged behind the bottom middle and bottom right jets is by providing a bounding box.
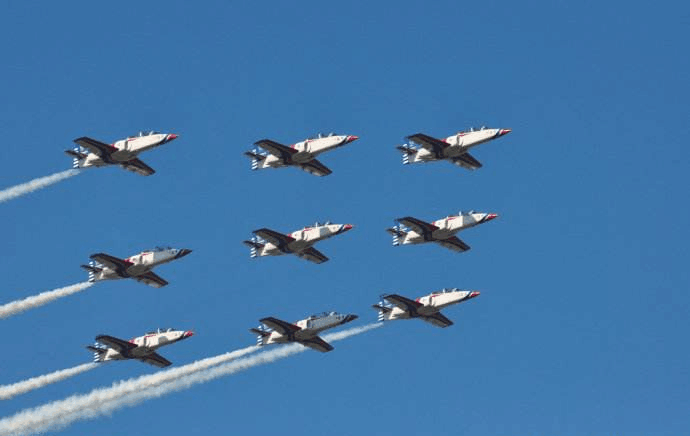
[0,323,383,435]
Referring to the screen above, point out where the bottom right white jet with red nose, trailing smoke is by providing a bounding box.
[372,288,479,327]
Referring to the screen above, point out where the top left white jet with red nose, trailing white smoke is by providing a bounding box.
[65,131,177,176]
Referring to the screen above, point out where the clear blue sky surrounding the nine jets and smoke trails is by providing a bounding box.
[0,1,690,436]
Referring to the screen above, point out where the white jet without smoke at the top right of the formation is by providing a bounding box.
[397,127,511,170]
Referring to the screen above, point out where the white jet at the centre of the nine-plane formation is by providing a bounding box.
[243,221,352,263]
